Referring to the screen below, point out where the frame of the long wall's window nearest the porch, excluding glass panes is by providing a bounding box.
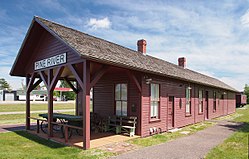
[149,83,161,121]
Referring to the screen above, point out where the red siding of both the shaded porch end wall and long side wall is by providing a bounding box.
[83,65,235,137]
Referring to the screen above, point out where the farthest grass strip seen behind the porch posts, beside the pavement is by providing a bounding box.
[0,103,75,112]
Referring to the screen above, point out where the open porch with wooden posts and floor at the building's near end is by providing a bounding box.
[26,61,141,149]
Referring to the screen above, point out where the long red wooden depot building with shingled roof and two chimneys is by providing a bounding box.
[10,17,237,149]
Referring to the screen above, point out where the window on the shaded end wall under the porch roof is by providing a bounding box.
[115,84,127,116]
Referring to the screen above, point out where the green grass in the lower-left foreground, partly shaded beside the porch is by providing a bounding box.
[0,131,115,159]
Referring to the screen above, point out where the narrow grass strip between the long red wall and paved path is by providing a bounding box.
[128,121,215,147]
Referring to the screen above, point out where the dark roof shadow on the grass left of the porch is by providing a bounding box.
[14,131,65,148]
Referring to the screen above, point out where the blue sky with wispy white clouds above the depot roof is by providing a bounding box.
[0,0,249,90]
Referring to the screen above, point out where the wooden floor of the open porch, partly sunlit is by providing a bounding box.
[28,130,140,148]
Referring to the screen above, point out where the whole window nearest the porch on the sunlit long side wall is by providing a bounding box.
[150,83,160,119]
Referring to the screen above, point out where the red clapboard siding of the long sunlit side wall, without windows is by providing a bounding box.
[141,76,235,136]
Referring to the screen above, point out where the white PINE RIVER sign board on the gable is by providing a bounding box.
[35,53,67,70]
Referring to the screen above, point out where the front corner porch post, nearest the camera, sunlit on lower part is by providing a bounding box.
[82,61,91,150]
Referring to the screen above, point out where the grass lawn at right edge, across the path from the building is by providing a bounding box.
[206,105,249,159]
